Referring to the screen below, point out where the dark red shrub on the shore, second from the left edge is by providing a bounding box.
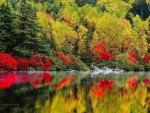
[18,58,29,70]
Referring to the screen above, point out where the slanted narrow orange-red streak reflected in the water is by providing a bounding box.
[54,76,74,89]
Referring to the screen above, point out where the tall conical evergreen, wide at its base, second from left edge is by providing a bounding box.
[13,0,49,57]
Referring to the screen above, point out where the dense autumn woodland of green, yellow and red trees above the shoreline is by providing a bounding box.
[0,0,150,71]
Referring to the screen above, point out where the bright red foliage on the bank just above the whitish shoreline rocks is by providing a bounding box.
[92,42,114,61]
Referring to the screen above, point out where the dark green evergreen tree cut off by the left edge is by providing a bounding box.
[0,2,14,52]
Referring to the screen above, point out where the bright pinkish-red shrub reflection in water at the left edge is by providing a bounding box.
[0,73,17,89]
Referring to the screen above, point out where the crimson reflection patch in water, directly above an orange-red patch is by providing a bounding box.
[99,80,115,90]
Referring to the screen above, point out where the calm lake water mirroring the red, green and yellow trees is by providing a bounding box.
[0,72,150,113]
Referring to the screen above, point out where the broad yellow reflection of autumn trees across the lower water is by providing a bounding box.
[35,77,148,113]
